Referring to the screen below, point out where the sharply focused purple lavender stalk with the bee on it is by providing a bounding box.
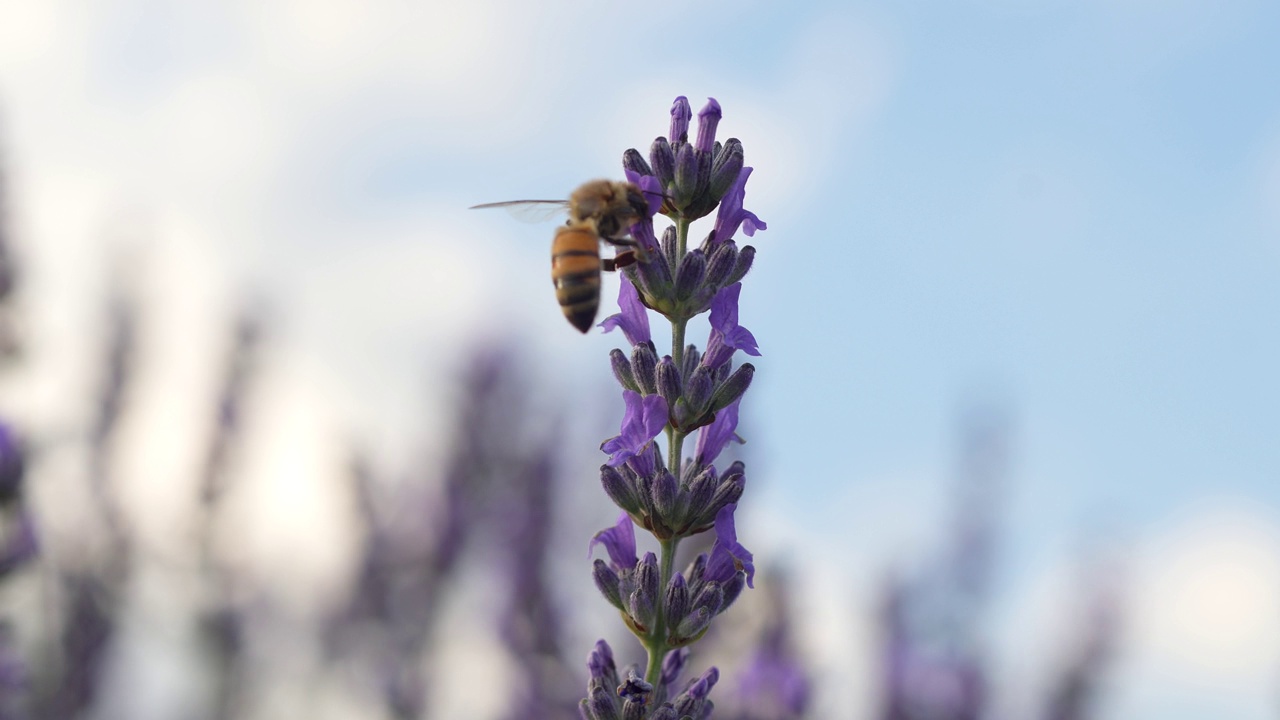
[580,97,765,720]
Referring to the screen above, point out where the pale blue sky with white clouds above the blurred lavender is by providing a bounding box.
[0,0,1280,720]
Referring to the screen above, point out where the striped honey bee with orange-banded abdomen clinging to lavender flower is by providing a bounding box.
[472,179,649,333]
